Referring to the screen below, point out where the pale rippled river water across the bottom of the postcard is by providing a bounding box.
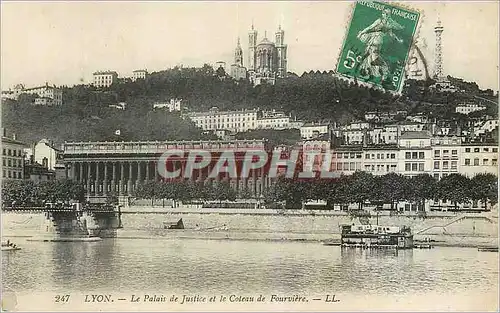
[2,237,498,310]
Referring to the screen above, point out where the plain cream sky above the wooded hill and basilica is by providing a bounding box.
[1,1,499,90]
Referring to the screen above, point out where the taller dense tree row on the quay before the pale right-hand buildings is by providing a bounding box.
[266,172,498,209]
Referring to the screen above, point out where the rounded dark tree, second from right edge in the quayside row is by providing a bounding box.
[437,174,471,210]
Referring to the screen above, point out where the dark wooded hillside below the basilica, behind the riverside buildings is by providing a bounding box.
[2,65,497,147]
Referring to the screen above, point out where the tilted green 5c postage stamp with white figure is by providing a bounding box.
[337,1,420,92]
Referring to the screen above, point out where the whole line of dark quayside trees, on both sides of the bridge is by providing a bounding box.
[2,172,498,209]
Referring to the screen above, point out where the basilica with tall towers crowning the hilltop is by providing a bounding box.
[230,25,287,85]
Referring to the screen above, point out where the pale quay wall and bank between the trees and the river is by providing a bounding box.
[2,208,498,247]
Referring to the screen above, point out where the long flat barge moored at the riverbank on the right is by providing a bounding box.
[340,224,414,249]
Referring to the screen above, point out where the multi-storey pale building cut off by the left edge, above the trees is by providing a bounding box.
[2,128,26,180]
